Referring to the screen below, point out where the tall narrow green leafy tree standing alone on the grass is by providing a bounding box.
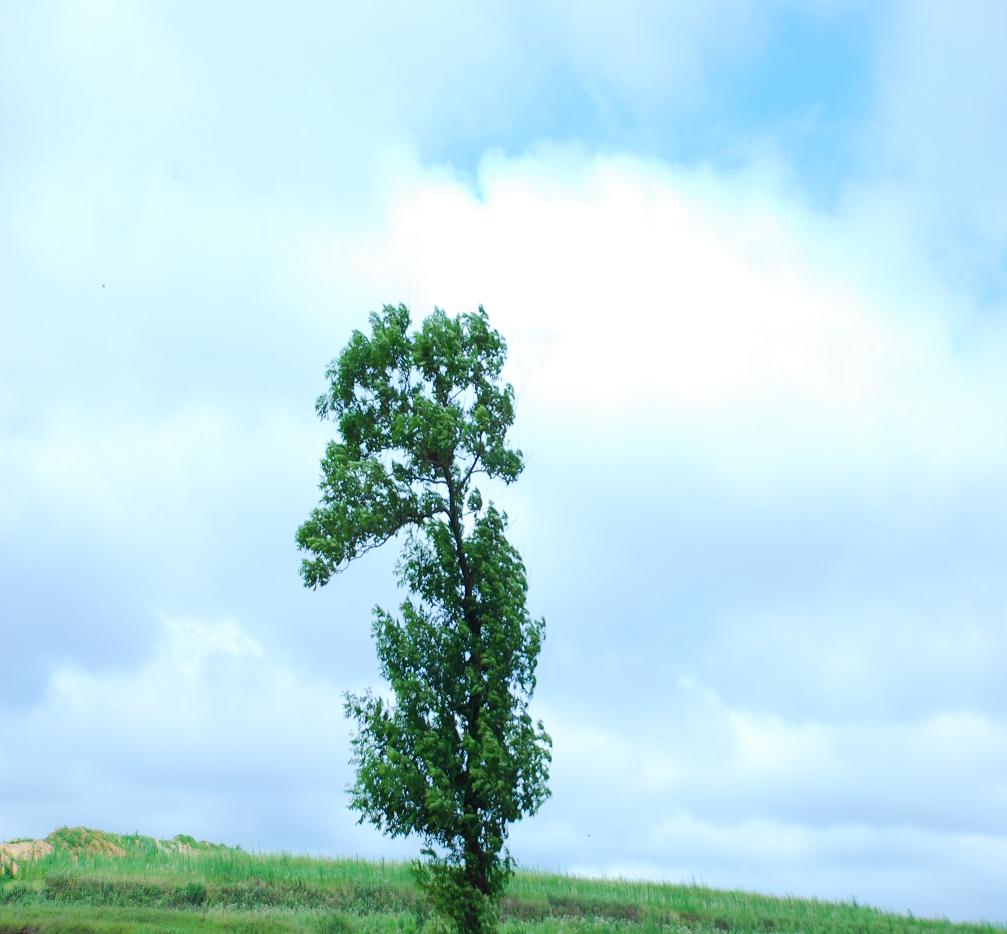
[297,305,551,932]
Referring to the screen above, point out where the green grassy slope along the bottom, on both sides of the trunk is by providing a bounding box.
[0,828,1007,934]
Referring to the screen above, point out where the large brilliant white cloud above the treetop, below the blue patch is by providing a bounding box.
[314,149,1007,486]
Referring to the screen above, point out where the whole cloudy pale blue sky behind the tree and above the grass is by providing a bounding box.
[0,0,1007,923]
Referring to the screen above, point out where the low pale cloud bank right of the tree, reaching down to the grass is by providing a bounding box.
[515,679,1007,919]
